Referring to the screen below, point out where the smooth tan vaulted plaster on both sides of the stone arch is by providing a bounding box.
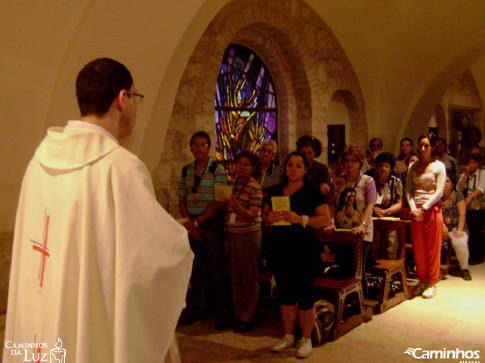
[0,0,485,230]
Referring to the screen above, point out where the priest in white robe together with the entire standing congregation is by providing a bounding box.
[3,58,485,362]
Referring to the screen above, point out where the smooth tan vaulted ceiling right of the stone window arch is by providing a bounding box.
[308,0,485,141]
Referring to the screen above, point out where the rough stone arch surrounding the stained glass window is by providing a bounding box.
[153,0,367,215]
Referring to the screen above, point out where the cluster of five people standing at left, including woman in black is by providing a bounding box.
[177,131,330,357]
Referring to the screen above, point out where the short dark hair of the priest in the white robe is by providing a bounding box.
[76,58,133,116]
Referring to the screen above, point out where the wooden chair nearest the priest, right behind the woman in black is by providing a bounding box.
[314,229,368,340]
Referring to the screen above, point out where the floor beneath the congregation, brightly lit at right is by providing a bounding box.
[177,264,485,362]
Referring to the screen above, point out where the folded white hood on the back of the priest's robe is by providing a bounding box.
[35,121,121,171]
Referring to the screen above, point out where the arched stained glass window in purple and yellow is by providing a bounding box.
[215,44,278,170]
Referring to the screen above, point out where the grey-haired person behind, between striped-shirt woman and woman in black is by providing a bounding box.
[252,139,283,191]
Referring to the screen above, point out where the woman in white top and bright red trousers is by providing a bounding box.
[405,133,446,299]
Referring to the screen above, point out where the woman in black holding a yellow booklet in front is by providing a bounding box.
[263,152,330,358]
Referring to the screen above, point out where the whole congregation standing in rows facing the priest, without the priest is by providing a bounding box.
[177,132,485,357]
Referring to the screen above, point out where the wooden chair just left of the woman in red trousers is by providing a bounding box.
[368,219,409,314]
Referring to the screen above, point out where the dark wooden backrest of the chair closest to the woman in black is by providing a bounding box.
[314,232,363,279]
